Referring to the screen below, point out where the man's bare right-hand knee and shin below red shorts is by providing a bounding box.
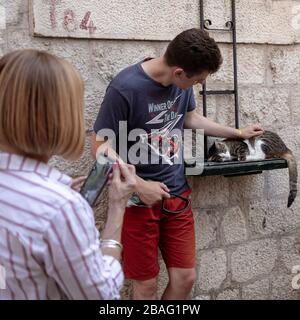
[162,268,196,300]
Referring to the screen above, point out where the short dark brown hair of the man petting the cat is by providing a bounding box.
[164,28,223,77]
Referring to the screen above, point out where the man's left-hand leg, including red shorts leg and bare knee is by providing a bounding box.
[122,207,160,300]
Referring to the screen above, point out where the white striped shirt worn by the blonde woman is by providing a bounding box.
[0,152,124,300]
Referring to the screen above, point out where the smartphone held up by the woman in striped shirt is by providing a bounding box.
[80,154,114,207]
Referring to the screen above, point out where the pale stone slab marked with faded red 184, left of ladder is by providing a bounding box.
[32,0,200,40]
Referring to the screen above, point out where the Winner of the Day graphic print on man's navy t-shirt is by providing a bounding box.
[140,94,183,165]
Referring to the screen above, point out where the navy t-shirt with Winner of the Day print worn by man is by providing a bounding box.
[94,62,196,194]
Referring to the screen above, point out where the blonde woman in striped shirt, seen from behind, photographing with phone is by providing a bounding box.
[0,50,135,299]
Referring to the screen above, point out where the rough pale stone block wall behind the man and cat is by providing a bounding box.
[0,0,300,299]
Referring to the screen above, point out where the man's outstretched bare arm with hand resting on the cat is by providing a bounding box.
[184,110,263,139]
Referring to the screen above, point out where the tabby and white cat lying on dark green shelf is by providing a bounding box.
[208,131,298,208]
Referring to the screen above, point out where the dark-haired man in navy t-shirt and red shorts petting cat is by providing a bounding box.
[92,29,263,299]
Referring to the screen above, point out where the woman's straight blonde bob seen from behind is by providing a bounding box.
[0,49,85,159]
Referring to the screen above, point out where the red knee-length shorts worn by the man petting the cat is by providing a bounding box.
[122,189,196,281]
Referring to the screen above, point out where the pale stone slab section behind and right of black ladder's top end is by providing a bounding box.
[205,0,300,44]
